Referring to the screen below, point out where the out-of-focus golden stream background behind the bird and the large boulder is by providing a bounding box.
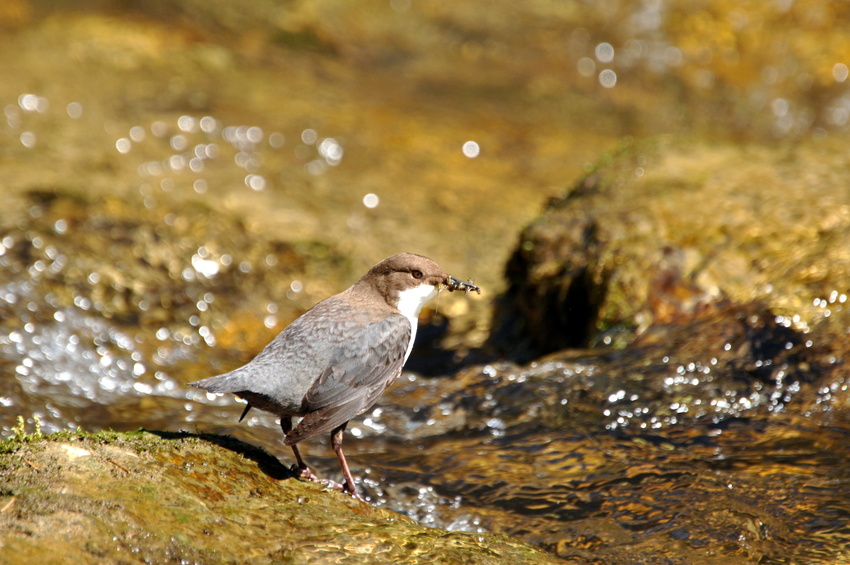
[0,0,850,560]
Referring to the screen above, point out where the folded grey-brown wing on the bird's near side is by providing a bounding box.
[286,315,411,445]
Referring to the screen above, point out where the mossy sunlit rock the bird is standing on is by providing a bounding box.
[0,432,557,565]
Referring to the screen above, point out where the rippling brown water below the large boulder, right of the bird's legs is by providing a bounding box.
[353,305,850,565]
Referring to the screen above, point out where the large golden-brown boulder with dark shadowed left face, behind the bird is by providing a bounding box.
[494,137,850,359]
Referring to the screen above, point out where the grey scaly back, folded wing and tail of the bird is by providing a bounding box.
[192,295,411,432]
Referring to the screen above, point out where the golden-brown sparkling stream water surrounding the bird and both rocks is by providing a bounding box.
[0,0,850,563]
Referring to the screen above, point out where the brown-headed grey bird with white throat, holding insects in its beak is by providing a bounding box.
[189,253,480,500]
